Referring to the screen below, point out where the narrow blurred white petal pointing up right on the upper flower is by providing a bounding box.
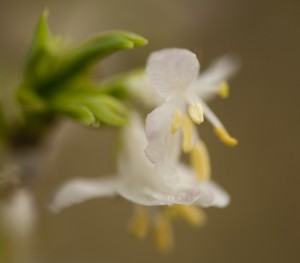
[191,55,240,99]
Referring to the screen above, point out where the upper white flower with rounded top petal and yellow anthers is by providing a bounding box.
[145,48,238,175]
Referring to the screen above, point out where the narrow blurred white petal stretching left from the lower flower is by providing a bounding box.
[50,177,118,212]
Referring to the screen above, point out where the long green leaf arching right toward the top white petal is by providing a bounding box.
[39,31,147,96]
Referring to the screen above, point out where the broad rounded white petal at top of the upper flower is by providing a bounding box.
[146,48,200,98]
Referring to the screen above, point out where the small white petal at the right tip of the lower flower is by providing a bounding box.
[197,180,230,208]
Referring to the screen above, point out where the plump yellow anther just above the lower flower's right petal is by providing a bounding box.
[190,142,211,180]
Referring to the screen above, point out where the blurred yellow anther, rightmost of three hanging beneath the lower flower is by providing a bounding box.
[172,205,206,227]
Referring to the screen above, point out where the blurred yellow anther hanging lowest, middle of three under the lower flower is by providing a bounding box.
[153,214,174,254]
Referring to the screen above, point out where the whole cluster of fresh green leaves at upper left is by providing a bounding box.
[17,11,147,133]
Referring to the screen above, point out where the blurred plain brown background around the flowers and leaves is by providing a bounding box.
[0,0,300,263]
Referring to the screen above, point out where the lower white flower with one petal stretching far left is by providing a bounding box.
[51,112,229,212]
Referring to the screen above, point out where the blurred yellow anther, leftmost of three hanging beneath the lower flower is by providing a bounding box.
[129,206,149,239]
